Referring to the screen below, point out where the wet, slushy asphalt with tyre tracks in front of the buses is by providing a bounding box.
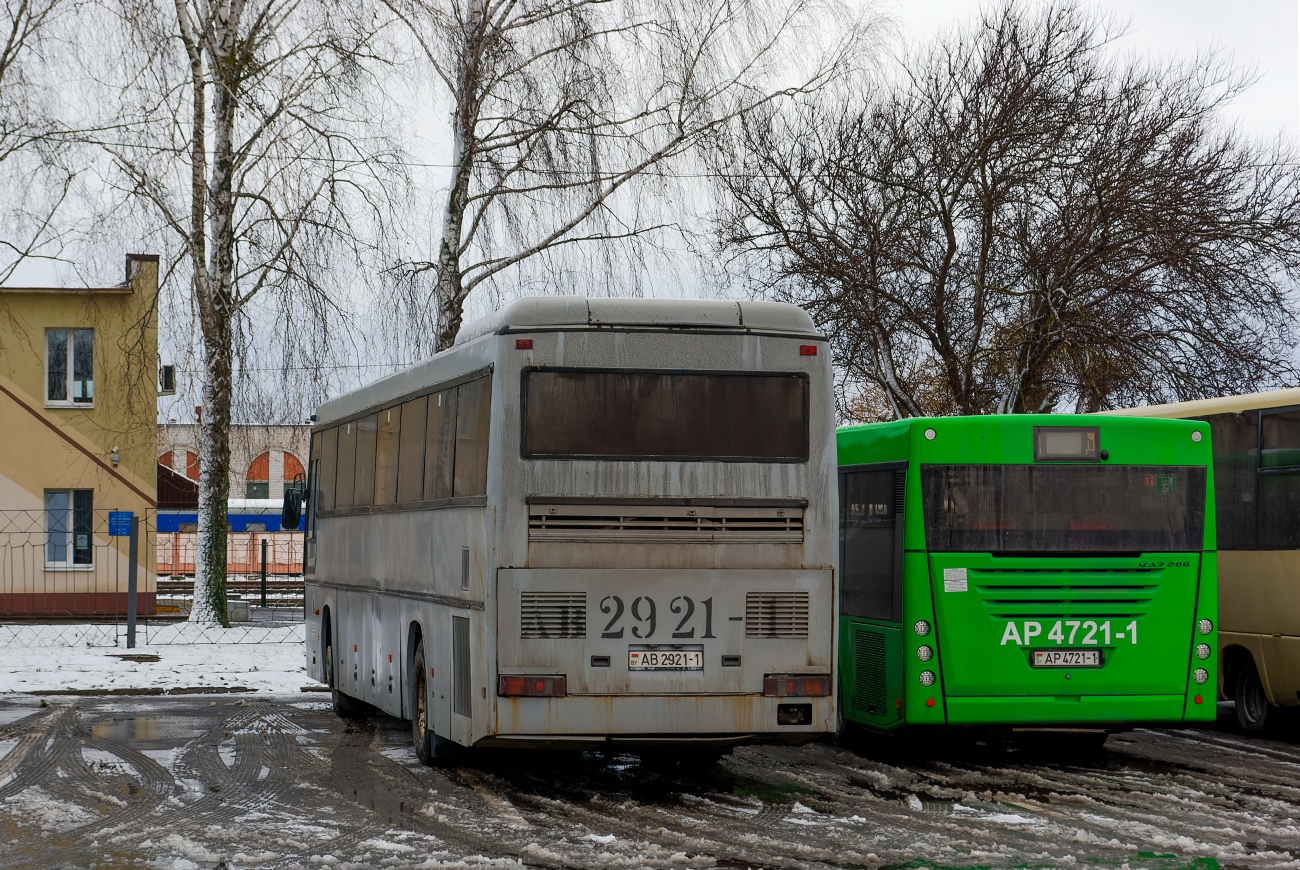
[0,694,1300,870]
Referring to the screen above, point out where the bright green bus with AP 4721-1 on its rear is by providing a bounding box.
[837,415,1218,739]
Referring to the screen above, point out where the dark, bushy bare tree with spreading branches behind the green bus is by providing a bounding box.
[723,3,1300,416]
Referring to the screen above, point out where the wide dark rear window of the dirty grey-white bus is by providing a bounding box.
[523,368,809,462]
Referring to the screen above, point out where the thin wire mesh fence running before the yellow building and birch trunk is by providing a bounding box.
[0,504,303,648]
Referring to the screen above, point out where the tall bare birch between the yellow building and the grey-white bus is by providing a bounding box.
[105,0,395,624]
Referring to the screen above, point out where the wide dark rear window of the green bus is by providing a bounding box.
[920,466,1205,553]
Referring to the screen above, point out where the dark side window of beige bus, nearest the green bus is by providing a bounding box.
[1201,411,1260,550]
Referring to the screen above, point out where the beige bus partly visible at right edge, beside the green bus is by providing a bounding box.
[1112,389,1300,732]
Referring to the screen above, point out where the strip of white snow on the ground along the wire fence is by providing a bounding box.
[0,623,319,693]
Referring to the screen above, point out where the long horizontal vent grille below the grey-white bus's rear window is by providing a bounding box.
[528,503,803,544]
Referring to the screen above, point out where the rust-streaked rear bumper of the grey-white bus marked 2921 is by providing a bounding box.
[491,694,836,743]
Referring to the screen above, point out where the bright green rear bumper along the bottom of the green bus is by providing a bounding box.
[945,693,1216,726]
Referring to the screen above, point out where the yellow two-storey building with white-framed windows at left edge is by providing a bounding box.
[0,255,159,616]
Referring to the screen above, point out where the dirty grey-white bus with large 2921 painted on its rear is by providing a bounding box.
[304,298,837,762]
